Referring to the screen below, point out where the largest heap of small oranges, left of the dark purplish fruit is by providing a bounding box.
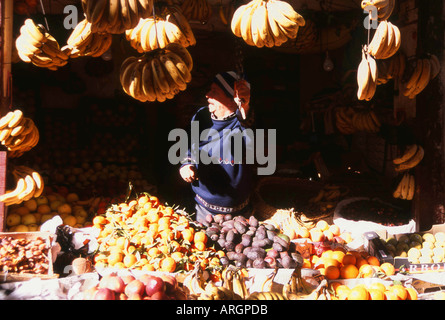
[93,194,224,273]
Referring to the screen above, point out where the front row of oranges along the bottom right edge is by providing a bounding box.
[329,282,417,300]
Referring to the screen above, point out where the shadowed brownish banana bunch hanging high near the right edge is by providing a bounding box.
[403,54,440,99]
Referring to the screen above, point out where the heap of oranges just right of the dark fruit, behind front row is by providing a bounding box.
[304,247,395,280]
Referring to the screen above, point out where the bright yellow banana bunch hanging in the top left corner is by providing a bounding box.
[15,19,68,71]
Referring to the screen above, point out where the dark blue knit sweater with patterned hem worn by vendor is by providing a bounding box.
[183,107,253,213]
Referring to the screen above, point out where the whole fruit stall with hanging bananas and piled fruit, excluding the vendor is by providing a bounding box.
[0,0,445,303]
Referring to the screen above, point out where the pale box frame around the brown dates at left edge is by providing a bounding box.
[0,231,58,283]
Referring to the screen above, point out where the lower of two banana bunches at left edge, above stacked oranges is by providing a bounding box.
[0,166,44,206]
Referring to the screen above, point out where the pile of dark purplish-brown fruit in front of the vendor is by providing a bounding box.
[205,214,302,269]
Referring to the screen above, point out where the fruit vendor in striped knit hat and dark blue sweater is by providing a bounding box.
[180,71,253,222]
